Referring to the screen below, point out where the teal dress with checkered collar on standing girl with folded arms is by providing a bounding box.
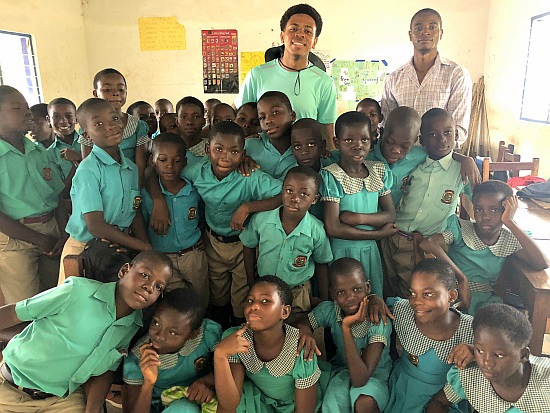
[320,161,392,296]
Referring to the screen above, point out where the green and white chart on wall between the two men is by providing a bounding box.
[331,60,388,110]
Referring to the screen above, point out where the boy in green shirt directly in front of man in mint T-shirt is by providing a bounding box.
[245,91,296,179]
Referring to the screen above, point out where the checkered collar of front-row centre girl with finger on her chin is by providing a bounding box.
[239,324,300,377]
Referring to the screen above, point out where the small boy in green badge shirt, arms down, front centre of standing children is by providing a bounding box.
[240,166,332,322]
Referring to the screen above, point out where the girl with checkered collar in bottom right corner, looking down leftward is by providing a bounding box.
[432,304,550,413]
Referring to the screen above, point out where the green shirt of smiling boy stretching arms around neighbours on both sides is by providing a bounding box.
[182,158,282,237]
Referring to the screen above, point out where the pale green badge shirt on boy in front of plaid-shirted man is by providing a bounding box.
[396,152,471,236]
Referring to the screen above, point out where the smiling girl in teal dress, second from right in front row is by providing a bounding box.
[369,258,473,413]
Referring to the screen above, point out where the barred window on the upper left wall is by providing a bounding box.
[0,30,43,106]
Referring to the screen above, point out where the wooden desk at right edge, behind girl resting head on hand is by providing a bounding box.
[499,196,550,356]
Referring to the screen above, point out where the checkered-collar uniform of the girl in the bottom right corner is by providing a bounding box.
[443,355,550,413]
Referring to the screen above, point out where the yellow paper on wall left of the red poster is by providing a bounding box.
[138,16,187,52]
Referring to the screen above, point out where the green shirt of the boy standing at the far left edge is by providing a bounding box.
[0,136,64,220]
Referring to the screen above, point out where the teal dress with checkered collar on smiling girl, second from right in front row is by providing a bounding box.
[385,300,474,413]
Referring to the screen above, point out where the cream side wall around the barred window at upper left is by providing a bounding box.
[0,0,91,104]
